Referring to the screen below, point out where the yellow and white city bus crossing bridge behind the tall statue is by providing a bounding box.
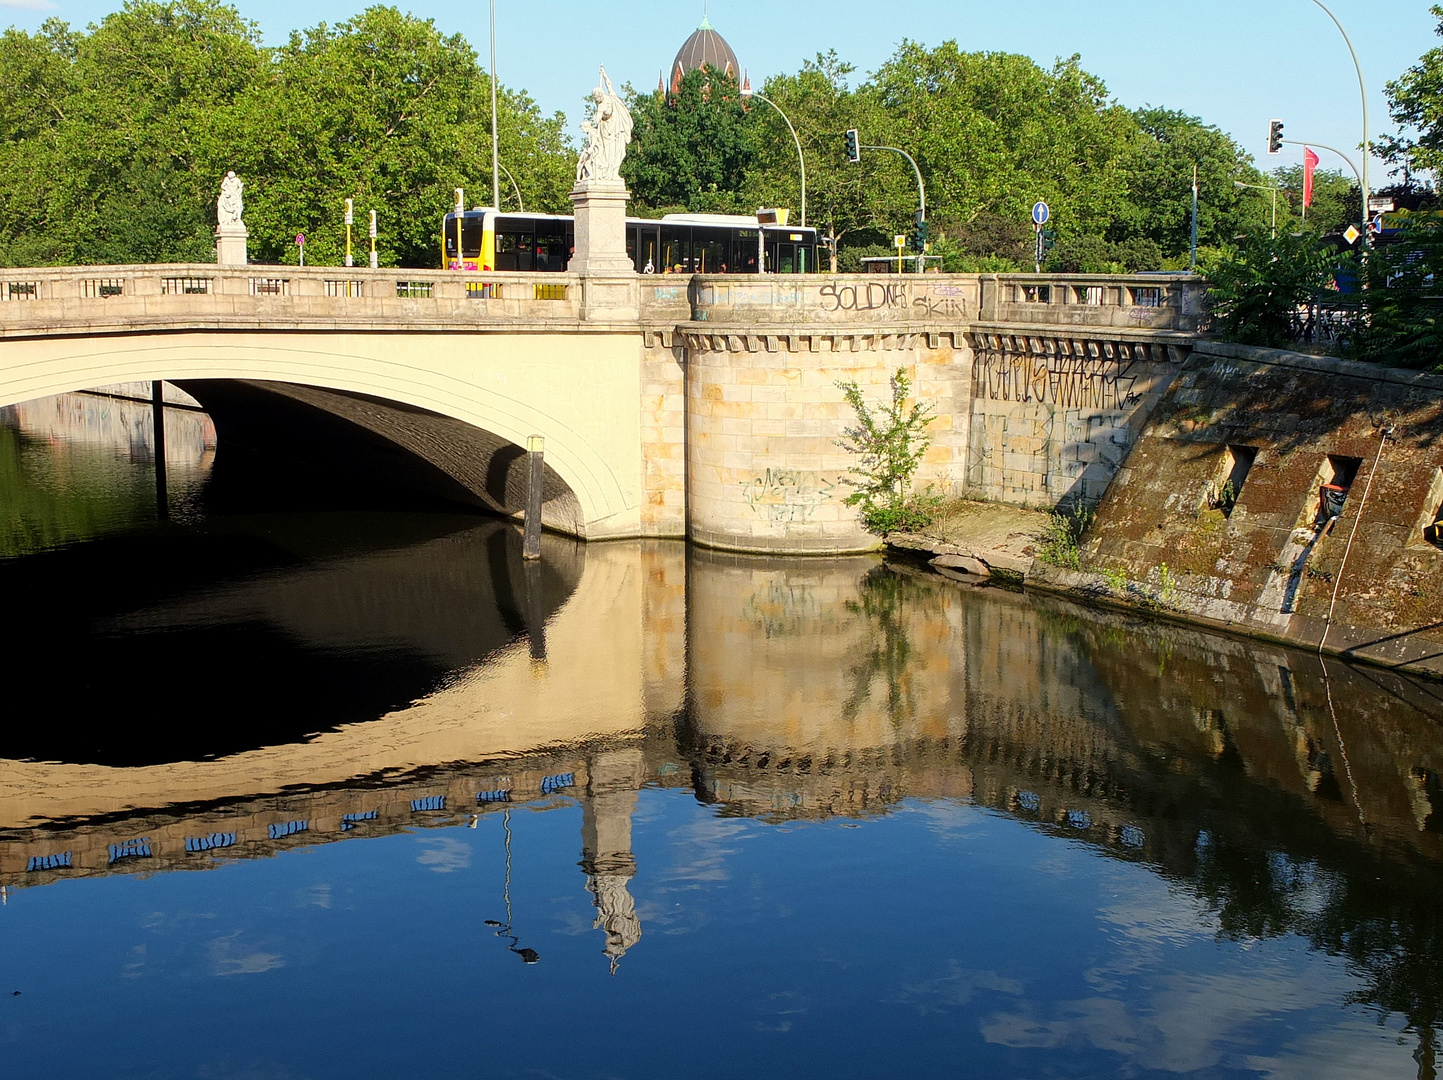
[440,208,817,274]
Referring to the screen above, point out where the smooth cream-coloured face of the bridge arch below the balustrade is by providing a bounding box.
[0,331,641,539]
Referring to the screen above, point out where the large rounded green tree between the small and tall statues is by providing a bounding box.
[231,7,571,266]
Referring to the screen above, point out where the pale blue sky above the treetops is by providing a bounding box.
[0,0,1443,186]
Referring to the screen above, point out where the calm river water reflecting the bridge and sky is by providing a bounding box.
[0,397,1443,1080]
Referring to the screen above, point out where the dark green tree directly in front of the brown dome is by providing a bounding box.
[622,69,756,212]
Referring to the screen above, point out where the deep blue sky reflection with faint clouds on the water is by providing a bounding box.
[0,788,1413,1080]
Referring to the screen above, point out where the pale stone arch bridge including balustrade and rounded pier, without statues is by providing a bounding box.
[0,264,1202,554]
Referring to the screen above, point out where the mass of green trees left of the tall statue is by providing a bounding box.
[0,0,574,266]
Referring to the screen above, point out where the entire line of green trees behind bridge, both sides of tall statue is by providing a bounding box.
[0,10,1419,270]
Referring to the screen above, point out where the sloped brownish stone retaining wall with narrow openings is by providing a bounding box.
[1029,342,1443,676]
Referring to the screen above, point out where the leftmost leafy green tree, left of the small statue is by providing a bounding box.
[0,0,264,263]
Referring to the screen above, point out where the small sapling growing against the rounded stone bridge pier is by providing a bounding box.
[837,368,942,536]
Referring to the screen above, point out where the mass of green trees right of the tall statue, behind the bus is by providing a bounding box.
[628,40,1268,270]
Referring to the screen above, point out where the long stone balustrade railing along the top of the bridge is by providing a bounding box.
[0,264,1203,335]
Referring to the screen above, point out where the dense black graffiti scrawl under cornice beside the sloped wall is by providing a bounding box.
[973,352,1139,409]
